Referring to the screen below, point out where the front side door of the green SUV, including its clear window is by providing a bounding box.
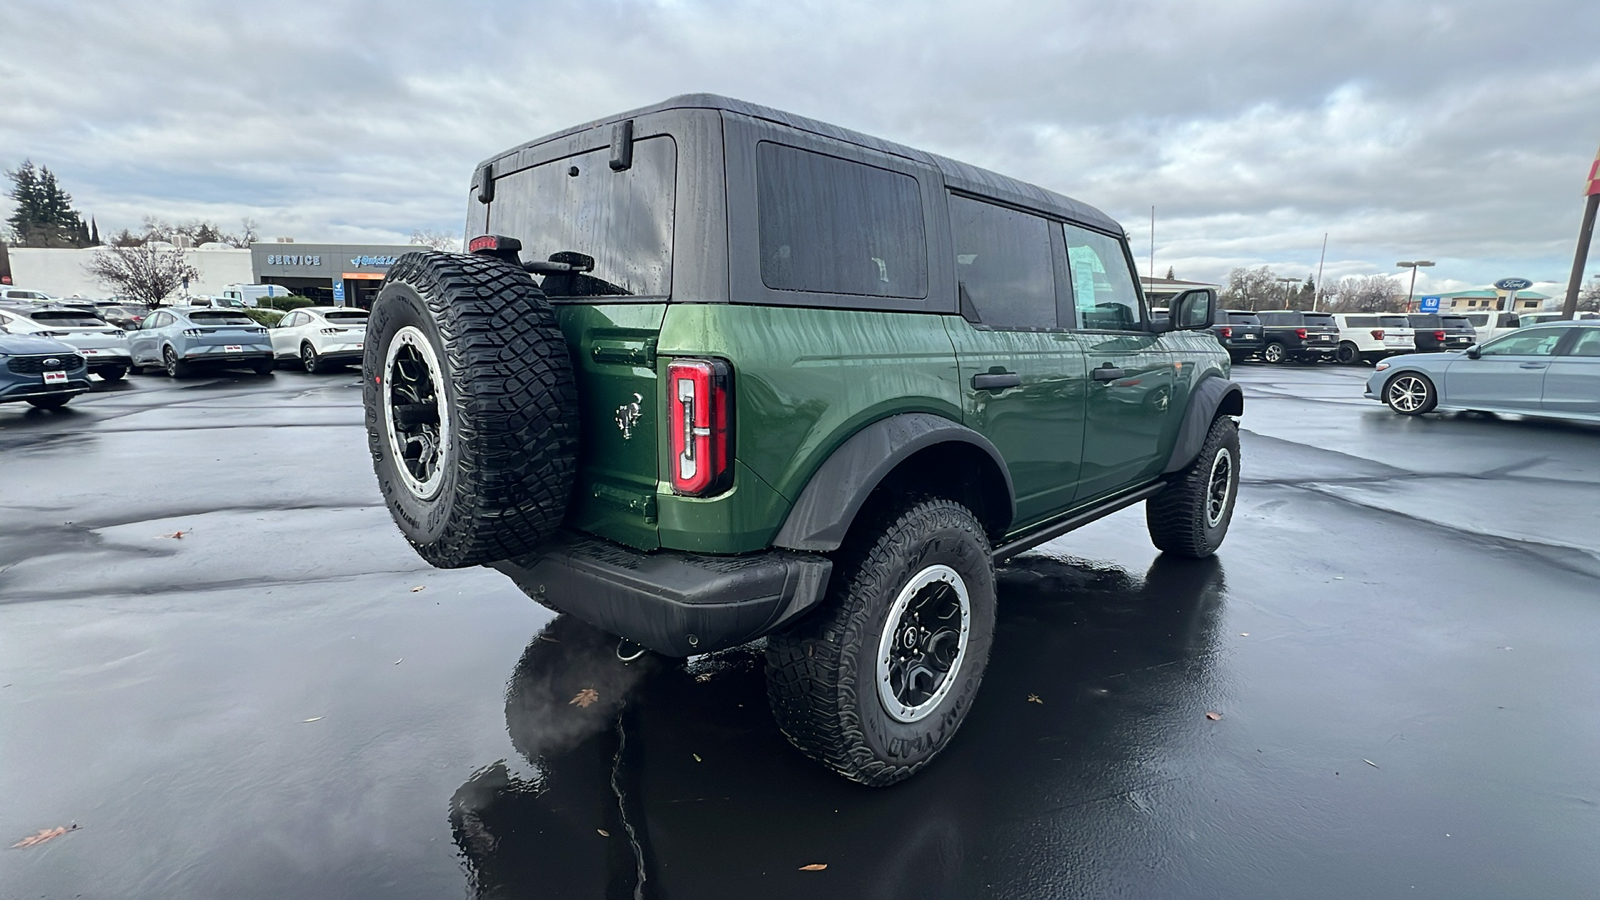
[1062,216,1174,503]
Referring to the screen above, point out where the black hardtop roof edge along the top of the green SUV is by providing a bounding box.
[485,93,1123,235]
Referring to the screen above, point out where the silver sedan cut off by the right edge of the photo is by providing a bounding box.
[1366,320,1600,423]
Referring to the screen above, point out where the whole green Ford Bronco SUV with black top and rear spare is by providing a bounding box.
[363,94,1243,785]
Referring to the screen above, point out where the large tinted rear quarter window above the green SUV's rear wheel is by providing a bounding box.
[755,141,928,299]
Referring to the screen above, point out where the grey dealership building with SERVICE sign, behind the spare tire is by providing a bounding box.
[250,242,424,309]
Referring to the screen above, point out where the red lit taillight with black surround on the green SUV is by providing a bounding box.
[666,359,733,496]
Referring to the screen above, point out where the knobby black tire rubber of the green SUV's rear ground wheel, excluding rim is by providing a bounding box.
[766,498,995,786]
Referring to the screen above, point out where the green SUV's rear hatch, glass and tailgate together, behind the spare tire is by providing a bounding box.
[469,127,678,549]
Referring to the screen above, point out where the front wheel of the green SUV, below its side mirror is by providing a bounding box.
[1144,416,1238,559]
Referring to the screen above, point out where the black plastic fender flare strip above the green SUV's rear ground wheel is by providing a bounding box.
[773,413,1016,552]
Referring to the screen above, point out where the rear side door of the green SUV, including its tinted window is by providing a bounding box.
[946,194,1085,527]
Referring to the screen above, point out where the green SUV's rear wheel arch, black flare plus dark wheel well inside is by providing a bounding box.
[773,413,1016,552]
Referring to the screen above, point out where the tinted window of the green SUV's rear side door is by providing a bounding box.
[950,197,1056,328]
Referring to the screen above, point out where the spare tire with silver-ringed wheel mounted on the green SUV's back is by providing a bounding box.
[362,251,578,569]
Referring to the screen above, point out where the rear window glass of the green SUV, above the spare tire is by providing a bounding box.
[488,136,678,298]
